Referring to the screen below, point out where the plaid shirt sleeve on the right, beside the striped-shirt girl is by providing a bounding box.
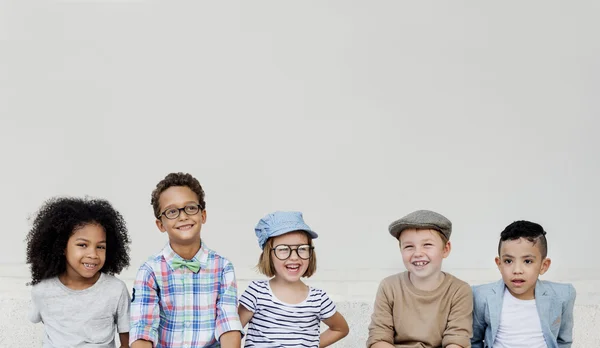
[215,261,243,340]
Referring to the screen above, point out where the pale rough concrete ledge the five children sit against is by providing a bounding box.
[0,298,600,348]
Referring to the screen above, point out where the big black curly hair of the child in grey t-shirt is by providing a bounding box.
[27,197,131,285]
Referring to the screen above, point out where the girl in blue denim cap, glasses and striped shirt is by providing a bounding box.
[238,211,349,348]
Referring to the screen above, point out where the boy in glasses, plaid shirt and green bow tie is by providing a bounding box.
[129,173,242,348]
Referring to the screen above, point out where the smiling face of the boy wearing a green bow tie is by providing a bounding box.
[156,186,206,251]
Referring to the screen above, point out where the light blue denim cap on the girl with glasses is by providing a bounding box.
[254,211,319,249]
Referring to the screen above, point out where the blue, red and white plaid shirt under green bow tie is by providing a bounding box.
[129,243,242,348]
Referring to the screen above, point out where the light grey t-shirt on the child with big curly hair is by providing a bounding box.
[29,273,130,348]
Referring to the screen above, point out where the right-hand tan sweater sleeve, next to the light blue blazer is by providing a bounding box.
[442,283,473,347]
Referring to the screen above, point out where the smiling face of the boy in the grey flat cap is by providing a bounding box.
[398,228,450,282]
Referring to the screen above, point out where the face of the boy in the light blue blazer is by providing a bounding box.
[495,238,550,300]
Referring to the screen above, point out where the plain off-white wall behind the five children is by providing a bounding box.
[0,0,600,304]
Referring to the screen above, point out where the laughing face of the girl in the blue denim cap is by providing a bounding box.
[271,232,309,283]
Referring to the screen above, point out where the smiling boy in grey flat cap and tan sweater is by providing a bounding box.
[367,210,473,348]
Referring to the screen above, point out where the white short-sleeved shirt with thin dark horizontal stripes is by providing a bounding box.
[240,280,336,348]
